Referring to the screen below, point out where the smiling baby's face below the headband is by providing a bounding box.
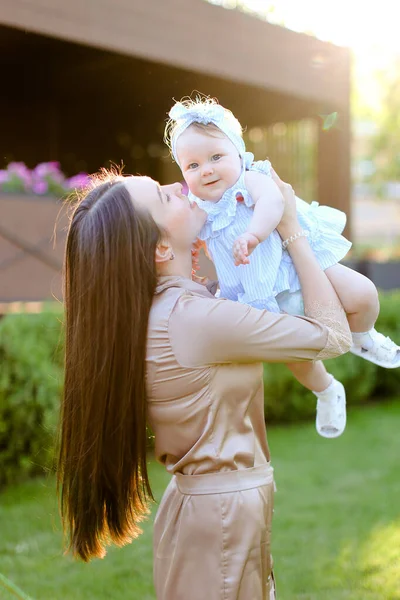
[176,126,242,202]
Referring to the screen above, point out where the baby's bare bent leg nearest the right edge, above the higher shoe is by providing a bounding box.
[325,264,379,332]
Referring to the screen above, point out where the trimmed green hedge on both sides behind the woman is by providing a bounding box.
[0,292,400,487]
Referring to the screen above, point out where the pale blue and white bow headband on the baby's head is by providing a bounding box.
[169,102,250,166]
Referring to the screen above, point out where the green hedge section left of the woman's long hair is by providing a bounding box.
[0,309,62,487]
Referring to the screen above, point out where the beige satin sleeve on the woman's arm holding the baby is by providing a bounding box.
[169,293,351,367]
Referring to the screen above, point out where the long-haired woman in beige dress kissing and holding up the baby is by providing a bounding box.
[59,169,351,600]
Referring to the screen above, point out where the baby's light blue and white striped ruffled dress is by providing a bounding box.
[189,160,351,314]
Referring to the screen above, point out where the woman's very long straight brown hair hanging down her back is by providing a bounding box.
[58,175,160,561]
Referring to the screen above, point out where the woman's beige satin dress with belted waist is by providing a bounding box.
[147,277,346,600]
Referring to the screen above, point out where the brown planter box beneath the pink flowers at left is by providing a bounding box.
[0,193,67,303]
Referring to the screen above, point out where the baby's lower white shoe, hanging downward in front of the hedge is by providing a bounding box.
[313,377,346,438]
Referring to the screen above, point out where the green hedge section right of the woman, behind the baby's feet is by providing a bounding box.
[264,291,400,423]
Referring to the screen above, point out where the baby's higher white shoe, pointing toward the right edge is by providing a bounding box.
[350,329,400,369]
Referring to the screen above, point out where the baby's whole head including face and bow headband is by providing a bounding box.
[165,98,246,202]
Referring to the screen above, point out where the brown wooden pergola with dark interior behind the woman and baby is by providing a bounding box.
[0,0,350,299]
